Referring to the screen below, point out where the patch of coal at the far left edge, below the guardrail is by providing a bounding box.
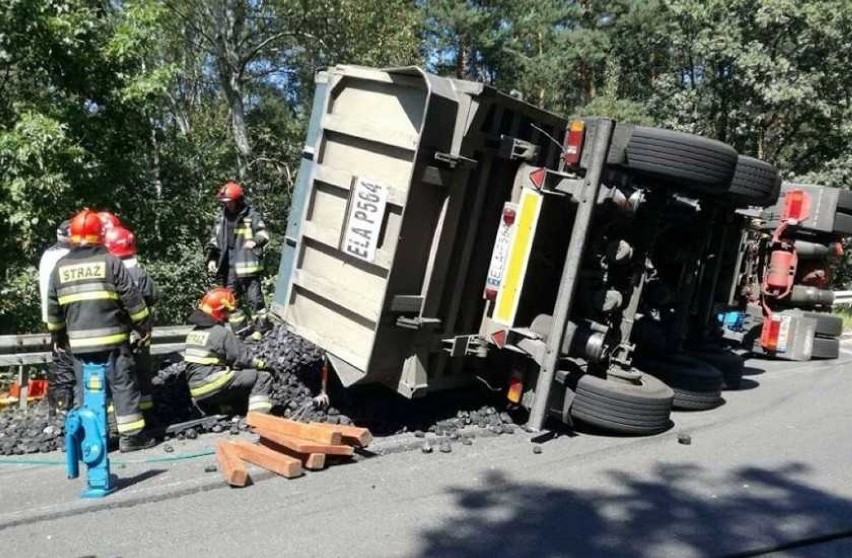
[0,400,65,455]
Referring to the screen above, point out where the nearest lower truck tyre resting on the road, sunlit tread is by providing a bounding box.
[571,374,674,434]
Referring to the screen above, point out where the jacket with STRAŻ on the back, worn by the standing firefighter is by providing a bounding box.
[47,246,150,353]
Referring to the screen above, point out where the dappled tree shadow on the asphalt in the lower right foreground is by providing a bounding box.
[420,464,852,558]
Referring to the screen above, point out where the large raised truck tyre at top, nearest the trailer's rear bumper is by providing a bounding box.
[623,126,737,194]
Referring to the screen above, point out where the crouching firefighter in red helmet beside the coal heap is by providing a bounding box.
[184,287,272,413]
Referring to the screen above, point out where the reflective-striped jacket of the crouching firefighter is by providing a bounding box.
[184,310,254,399]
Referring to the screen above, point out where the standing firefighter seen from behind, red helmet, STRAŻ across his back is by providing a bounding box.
[47,209,156,452]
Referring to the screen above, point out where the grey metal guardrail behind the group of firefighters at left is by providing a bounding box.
[0,326,192,368]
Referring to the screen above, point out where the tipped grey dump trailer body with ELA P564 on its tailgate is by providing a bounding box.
[276,66,566,396]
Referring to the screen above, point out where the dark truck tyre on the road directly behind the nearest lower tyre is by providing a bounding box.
[637,354,723,411]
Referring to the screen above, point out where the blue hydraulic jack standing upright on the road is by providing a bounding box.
[65,362,116,498]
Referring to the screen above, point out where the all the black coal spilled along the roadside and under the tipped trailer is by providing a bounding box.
[0,325,519,455]
